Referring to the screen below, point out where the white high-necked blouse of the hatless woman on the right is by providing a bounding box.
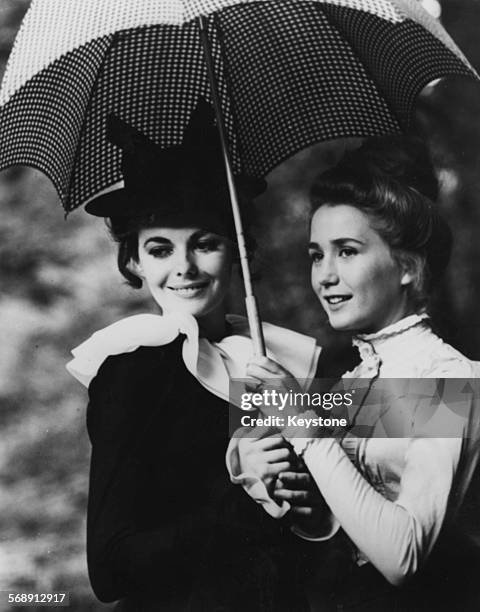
[291,315,478,585]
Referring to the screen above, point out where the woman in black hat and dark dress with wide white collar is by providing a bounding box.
[65,103,316,612]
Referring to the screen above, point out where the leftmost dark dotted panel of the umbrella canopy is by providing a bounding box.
[0,38,110,202]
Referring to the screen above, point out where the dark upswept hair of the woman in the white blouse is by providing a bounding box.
[310,136,452,309]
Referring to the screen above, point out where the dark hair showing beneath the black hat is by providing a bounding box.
[106,213,256,289]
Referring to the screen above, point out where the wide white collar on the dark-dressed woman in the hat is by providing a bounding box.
[66,313,320,403]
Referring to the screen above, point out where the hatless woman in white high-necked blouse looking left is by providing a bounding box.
[241,139,479,610]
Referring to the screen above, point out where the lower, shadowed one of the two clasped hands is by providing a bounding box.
[274,465,329,537]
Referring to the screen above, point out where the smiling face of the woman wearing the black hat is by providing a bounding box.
[133,227,232,319]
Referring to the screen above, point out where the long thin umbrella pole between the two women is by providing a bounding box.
[197,16,266,357]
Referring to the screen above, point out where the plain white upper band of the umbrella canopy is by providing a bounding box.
[0,0,408,106]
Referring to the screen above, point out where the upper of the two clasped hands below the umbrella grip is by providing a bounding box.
[238,428,292,495]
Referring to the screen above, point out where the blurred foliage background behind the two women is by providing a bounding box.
[0,0,480,612]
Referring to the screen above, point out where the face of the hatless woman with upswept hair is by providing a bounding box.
[309,204,412,333]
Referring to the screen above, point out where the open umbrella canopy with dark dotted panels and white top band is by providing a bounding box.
[0,0,475,354]
